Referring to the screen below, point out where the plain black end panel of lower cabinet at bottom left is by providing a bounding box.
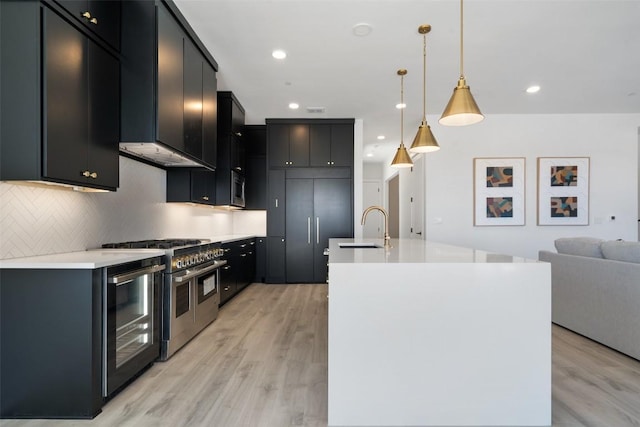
[0,269,103,418]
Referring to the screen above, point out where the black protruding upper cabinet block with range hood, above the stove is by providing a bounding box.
[121,0,218,170]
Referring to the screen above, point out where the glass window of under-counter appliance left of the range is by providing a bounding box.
[115,274,153,368]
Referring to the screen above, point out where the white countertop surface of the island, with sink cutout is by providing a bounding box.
[329,239,538,264]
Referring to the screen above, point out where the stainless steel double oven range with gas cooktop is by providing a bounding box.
[103,239,226,360]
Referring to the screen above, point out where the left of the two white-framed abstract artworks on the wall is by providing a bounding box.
[473,157,525,226]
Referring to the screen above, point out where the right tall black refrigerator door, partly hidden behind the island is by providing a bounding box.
[312,178,353,283]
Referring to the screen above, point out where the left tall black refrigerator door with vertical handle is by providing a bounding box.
[286,178,314,283]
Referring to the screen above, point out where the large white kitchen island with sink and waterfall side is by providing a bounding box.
[328,239,551,426]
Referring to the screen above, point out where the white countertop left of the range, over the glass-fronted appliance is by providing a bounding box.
[0,249,164,269]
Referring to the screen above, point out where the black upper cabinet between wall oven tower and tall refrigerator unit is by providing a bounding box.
[244,125,267,210]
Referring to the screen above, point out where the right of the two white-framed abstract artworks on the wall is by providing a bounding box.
[538,157,589,225]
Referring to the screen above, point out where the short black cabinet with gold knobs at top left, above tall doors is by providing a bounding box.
[56,0,120,50]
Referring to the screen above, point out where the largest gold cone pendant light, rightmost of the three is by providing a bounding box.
[438,0,484,126]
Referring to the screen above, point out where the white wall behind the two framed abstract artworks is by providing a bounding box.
[384,114,640,259]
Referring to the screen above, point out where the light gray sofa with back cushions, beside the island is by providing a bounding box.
[538,237,640,360]
